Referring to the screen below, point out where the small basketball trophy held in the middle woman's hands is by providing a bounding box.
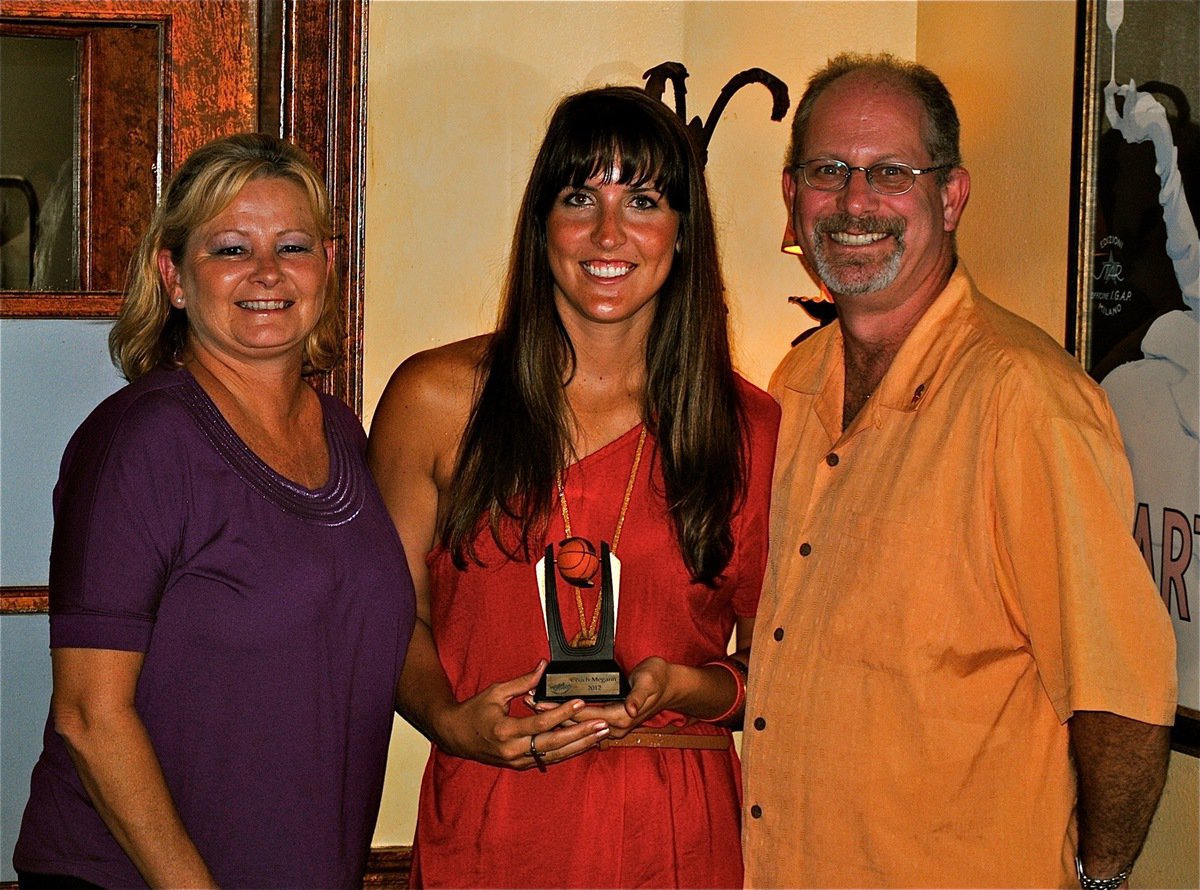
[534,537,629,703]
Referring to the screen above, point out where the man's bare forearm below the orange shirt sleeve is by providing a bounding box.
[1069,711,1171,878]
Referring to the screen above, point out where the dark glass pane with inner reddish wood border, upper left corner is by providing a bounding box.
[0,18,159,294]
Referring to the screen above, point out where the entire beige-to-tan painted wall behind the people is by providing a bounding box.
[364,0,1198,886]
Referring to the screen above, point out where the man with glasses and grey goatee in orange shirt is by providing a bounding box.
[743,56,1176,890]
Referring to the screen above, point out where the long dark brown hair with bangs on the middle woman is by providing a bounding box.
[440,86,746,584]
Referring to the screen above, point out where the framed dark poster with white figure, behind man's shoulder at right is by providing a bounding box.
[1073,0,1200,756]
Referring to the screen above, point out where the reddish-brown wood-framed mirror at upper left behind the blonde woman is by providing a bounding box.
[0,0,258,318]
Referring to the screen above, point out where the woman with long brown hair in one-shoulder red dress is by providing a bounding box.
[370,88,778,888]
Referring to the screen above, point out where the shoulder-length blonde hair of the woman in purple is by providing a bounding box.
[108,133,346,381]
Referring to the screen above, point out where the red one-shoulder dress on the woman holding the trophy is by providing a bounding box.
[413,381,779,888]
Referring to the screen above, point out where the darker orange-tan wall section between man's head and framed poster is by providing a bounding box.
[916,1,1075,343]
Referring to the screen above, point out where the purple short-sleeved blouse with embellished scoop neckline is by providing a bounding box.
[13,371,414,888]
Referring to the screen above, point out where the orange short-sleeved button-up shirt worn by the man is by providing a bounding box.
[743,266,1176,888]
